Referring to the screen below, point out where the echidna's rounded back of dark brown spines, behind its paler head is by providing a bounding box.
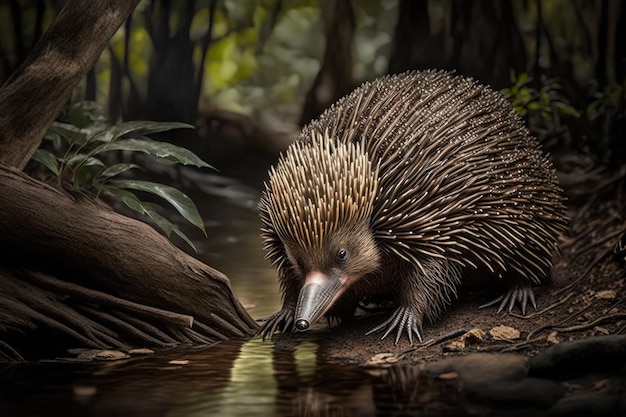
[299,71,566,283]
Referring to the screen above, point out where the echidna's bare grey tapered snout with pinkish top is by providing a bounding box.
[296,271,344,330]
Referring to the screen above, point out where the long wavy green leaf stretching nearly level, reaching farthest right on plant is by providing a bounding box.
[92,139,213,168]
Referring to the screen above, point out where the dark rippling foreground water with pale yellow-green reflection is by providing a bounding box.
[0,338,472,417]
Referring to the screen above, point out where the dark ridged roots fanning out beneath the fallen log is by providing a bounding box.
[0,269,232,361]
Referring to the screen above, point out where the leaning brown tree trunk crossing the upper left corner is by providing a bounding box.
[0,0,139,169]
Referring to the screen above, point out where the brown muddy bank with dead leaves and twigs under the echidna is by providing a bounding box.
[274,187,626,366]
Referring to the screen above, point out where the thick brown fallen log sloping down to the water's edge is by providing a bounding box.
[0,167,257,358]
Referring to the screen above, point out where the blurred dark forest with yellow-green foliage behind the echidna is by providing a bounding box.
[0,0,626,172]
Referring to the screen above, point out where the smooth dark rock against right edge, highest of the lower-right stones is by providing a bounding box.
[528,335,626,379]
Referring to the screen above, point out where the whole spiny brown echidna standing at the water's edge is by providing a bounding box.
[260,71,566,343]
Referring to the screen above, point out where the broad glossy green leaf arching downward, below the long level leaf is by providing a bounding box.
[110,180,206,235]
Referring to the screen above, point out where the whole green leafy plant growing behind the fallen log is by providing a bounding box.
[33,105,212,250]
